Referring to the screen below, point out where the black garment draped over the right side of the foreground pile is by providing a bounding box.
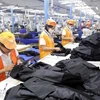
[55,58,100,96]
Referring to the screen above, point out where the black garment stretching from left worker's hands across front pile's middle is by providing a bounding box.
[10,62,83,87]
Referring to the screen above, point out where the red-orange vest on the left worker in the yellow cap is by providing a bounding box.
[0,50,17,82]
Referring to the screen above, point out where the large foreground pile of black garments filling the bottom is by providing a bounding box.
[4,58,100,100]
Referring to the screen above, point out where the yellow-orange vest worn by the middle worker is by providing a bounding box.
[39,32,54,59]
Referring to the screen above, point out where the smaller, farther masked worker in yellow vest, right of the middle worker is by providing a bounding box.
[62,20,75,46]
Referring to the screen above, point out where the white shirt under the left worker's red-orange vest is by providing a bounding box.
[0,49,19,67]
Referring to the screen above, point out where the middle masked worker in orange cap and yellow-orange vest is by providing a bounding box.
[39,19,60,59]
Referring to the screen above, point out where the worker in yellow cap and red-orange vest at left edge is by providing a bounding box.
[0,32,21,81]
